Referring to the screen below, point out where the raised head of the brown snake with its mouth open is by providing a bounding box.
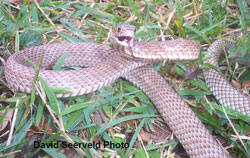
[111,24,136,51]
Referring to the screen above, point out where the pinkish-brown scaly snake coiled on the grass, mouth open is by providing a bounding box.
[4,24,250,158]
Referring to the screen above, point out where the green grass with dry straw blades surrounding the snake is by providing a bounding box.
[0,0,250,157]
